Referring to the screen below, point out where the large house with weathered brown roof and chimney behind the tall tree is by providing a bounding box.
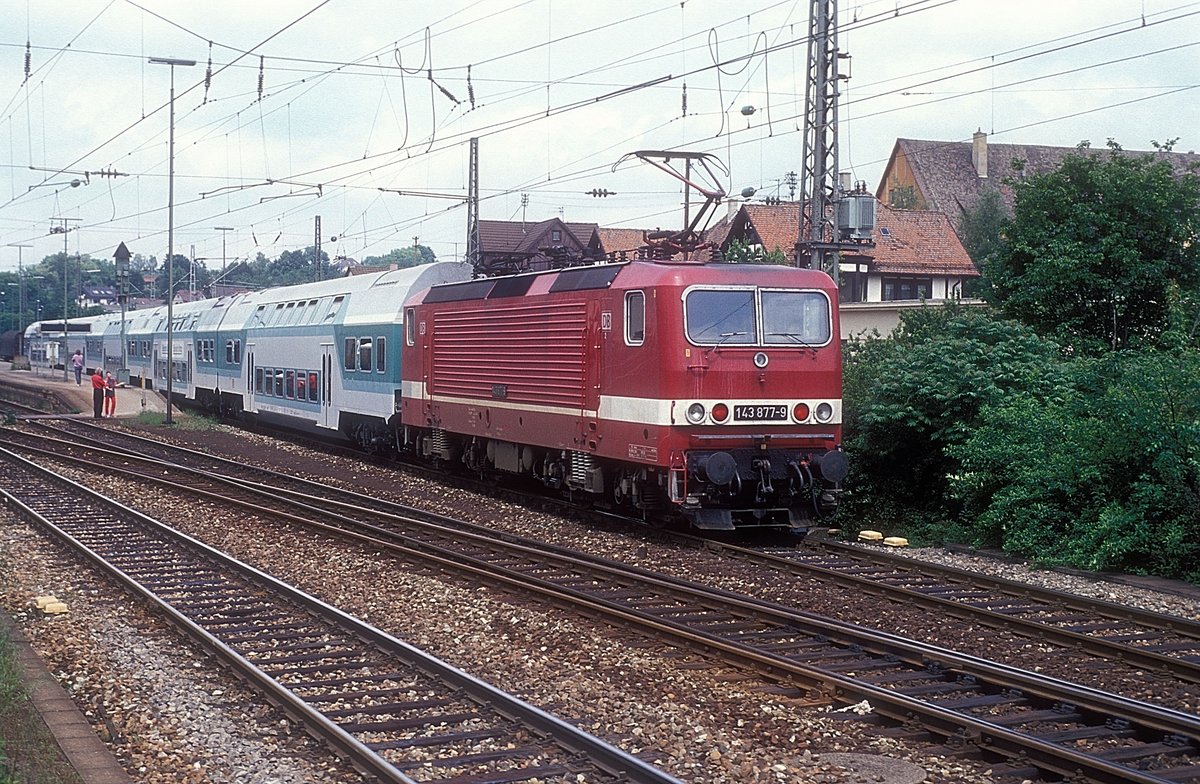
[875,131,1200,225]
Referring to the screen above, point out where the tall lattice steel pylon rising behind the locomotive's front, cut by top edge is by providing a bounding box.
[796,0,850,274]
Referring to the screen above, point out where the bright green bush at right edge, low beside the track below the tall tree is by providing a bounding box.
[953,347,1200,580]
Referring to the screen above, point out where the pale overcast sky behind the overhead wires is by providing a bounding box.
[0,0,1200,270]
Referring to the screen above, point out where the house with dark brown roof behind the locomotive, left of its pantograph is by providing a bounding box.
[479,217,604,271]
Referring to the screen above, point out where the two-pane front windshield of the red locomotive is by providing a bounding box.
[684,288,830,346]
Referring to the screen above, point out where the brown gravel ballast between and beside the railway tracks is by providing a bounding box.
[0,429,1198,783]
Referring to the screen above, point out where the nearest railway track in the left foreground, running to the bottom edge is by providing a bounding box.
[0,450,677,784]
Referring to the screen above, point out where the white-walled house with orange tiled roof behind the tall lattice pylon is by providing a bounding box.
[704,202,979,339]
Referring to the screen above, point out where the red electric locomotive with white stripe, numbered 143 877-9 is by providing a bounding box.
[396,261,847,529]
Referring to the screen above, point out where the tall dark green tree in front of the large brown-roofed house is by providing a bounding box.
[984,142,1200,353]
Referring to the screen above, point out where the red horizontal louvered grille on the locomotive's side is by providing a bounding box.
[431,303,587,408]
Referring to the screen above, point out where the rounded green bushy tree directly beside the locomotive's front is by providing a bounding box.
[842,303,1062,540]
